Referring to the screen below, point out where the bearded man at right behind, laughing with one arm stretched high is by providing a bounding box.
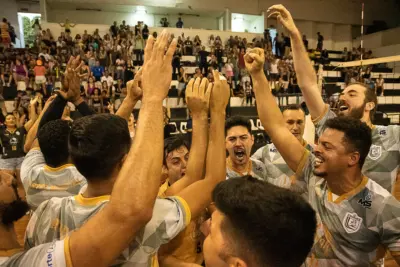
[274,6,400,198]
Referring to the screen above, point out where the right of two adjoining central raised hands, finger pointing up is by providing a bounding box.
[208,70,230,112]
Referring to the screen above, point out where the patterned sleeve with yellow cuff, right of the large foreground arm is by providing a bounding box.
[138,197,191,255]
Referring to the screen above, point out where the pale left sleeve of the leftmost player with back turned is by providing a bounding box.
[21,149,46,189]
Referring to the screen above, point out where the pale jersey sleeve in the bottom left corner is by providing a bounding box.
[1,240,66,267]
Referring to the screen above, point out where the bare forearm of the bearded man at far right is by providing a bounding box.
[290,30,325,118]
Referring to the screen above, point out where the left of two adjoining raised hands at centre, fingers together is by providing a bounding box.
[186,78,212,116]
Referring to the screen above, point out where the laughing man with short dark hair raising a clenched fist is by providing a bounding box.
[245,5,400,267]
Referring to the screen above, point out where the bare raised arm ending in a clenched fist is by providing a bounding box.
[245,48,304,171]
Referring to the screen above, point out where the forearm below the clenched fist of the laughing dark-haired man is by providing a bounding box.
[252,72,285,138]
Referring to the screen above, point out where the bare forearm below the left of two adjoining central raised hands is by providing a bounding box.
[165,112,208,196]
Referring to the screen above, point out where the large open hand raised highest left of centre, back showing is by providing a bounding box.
[142,30,176,101]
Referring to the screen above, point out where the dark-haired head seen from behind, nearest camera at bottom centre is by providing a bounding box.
[212,176,317,267]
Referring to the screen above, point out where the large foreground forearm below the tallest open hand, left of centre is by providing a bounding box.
[110,101,164,219]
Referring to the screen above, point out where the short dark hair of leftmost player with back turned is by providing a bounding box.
[37,120,70,167]
